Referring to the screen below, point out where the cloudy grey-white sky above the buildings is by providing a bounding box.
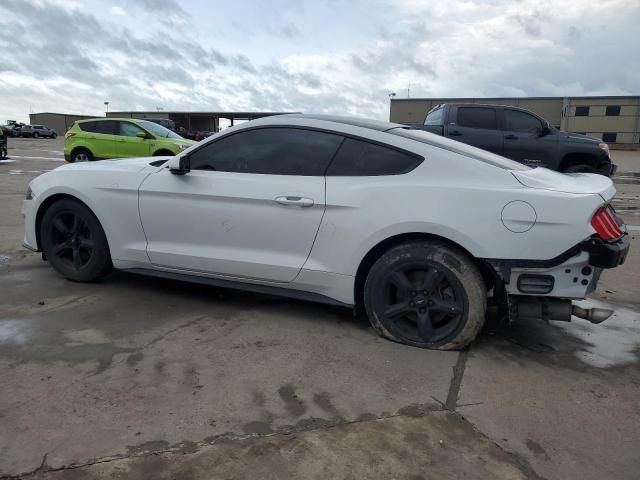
[0,0,640,123]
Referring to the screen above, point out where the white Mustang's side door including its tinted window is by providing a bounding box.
[139,127,343,282]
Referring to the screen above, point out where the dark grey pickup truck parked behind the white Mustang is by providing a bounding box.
[413,103,616,176]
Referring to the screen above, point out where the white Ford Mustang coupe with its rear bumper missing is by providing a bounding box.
[23,115,629,349]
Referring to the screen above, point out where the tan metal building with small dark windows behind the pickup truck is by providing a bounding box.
[389,96,640,148]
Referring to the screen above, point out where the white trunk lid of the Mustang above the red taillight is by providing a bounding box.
[511,167,616,201]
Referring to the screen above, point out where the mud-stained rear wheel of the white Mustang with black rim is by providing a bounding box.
[364,241,487,350]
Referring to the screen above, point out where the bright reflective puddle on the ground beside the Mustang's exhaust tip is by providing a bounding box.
[553,299,640,368]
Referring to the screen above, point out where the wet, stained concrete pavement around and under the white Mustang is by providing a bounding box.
[0,140,640,480]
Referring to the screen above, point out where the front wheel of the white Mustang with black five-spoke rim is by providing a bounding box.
[40,198,113,282]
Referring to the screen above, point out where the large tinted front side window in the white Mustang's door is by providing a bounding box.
[189,128,343,176]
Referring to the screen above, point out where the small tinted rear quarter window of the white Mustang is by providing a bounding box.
[327,138,422,177]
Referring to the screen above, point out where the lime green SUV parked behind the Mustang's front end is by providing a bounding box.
[64,118,196,163]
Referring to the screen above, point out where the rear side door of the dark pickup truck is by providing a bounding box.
[447,105,502,154]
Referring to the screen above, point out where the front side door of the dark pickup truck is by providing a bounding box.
[502,108,558,167]
